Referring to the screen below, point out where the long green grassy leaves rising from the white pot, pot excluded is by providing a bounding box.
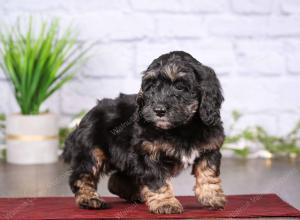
[0,18,90,115]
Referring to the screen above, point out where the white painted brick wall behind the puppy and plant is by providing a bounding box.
[0,0,300,133]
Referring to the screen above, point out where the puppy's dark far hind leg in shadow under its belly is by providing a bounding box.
[108,172,143,203]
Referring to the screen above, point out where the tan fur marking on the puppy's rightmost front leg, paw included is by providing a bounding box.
[193,160,226,209]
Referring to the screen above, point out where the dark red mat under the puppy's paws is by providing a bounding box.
[0,194,300,219]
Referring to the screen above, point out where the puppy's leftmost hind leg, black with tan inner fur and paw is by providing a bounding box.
[69,148,107,209]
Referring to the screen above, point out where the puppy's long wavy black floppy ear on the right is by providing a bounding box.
[195,63,224,126]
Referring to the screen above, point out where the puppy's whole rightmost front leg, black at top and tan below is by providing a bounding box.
[193,150,226,209]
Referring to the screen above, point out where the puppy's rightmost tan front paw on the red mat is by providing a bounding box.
[196,185,226,209]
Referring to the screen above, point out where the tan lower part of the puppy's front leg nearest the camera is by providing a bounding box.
[141,181,183,214]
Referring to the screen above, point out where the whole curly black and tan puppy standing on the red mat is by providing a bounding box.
[63,51,225,214]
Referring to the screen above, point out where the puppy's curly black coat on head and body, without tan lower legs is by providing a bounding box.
[63,51,224,211]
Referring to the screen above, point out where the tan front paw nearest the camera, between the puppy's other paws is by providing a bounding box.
[149,198,183,214]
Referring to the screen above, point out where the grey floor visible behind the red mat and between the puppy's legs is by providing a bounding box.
[0,158,300,218]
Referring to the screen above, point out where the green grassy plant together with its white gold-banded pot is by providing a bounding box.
[0,18,89,164]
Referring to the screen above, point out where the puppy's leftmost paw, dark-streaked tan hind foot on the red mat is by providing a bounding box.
[75,192,108,209]
